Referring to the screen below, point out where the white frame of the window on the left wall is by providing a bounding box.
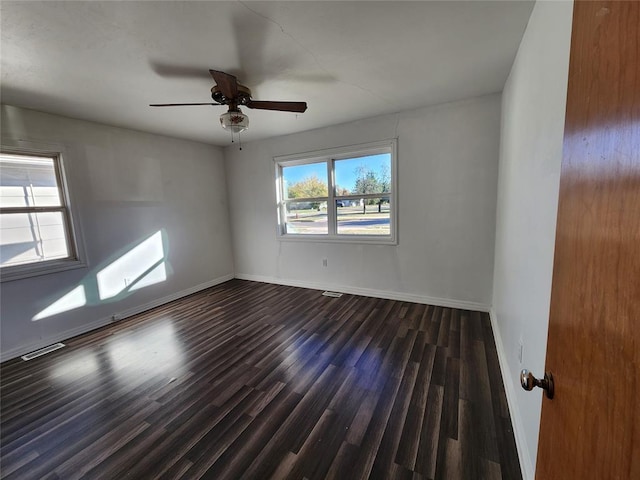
[0,138,86,282]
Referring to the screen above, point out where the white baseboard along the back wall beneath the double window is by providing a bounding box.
[236,273,489,312]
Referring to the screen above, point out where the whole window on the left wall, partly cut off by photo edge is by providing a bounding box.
[0,148,80,280]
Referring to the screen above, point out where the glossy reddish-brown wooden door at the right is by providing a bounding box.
[536,0,640,480]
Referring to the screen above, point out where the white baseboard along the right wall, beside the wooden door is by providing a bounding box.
[489,308,535,480]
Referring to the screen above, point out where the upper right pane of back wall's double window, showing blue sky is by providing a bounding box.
[334,153,391,197]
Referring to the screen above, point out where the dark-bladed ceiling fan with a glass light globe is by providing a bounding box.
[149,70,307,134]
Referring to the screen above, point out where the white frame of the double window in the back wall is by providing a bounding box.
[273,138,398,245]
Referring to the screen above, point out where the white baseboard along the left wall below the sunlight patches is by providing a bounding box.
[0,274,234,362]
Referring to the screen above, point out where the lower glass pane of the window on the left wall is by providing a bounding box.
[0,212,69,267]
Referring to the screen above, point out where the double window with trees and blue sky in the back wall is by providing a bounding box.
[275,139,397,244]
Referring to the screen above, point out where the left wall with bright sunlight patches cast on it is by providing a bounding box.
[0,105,233,360]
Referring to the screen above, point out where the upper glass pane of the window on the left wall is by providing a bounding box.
[0,153,61,207]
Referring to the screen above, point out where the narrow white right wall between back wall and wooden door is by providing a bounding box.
[492,1,573,479]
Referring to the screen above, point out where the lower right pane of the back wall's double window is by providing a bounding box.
[336,197,391,235]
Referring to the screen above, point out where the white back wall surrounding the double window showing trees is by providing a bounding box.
[225,94,500,310]
